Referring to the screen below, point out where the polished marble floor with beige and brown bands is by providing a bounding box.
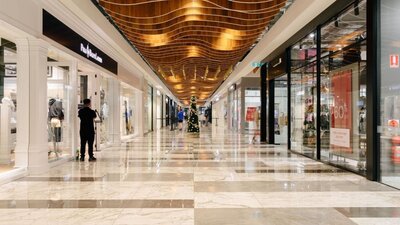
[0,128,400,225]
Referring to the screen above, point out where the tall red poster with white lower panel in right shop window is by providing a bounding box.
[330,70,352,151]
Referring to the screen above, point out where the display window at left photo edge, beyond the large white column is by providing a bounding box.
[0,38,17,172]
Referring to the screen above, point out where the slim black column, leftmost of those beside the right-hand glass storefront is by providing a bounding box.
[260,64,267,142]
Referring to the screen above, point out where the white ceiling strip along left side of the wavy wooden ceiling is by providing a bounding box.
[42,0,179,102]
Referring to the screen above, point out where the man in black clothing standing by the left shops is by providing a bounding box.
[78,99,96,161]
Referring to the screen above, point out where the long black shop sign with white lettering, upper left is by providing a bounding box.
[42,10,118,75]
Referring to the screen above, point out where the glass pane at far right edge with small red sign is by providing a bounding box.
[378,0,400,188]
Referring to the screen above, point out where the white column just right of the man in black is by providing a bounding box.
[109,78,121,146]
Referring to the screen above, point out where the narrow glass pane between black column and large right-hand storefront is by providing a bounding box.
[274,75,288,144]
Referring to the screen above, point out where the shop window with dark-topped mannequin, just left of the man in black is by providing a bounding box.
[47,66,72,160]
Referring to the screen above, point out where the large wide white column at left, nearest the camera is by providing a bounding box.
[15,39,49,174]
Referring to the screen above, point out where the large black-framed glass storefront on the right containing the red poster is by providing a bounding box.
[255,0,368,175]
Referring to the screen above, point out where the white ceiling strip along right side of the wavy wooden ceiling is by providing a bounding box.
[207,0,336,103]
